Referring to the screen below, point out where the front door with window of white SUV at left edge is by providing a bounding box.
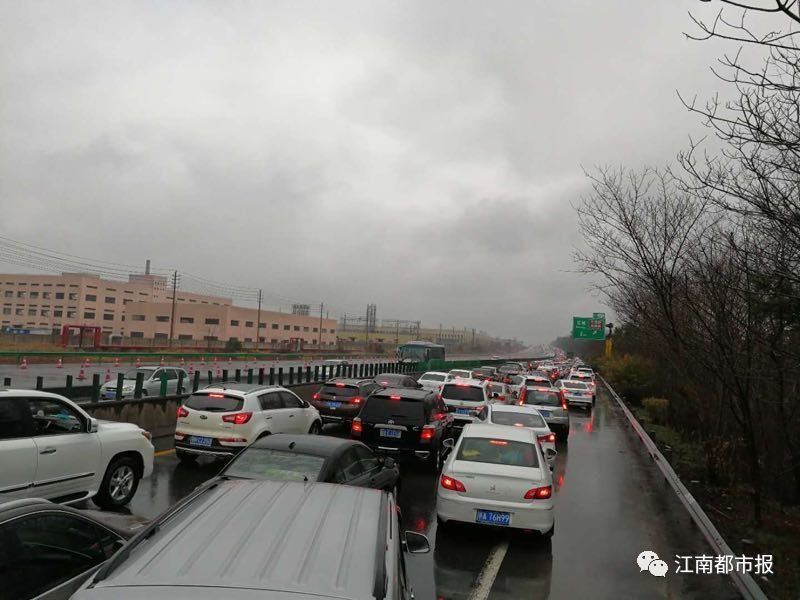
[25,397,104,498]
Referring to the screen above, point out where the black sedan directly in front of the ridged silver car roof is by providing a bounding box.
[219,433,400,492]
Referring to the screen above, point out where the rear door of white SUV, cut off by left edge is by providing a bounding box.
[0,397,37,500]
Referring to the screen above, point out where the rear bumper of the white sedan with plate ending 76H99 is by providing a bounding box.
[436,492,555,533]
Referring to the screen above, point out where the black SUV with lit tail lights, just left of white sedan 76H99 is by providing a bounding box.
[350,388,453,469]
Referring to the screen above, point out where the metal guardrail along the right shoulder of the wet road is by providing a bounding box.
[598,375,767,600]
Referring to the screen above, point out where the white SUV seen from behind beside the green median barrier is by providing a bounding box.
[175,382,322,462]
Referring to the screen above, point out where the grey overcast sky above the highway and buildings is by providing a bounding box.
[0,0,736,343]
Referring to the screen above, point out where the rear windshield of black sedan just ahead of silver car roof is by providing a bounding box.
[221,447,325,481]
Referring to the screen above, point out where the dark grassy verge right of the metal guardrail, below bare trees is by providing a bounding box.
[627,404,800,599]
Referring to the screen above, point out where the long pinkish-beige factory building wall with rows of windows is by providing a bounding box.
[0,274,337,347]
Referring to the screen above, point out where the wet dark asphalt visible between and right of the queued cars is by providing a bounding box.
[104,386,739,600]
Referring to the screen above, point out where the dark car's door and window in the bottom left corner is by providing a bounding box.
[0,510,124,600]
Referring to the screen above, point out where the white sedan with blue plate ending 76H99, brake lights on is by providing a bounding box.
[436,424,555,537]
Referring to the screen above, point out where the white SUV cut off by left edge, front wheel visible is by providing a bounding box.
[0,389,153,508]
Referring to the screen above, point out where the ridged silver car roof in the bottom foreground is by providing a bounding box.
[84,480,388,599]
